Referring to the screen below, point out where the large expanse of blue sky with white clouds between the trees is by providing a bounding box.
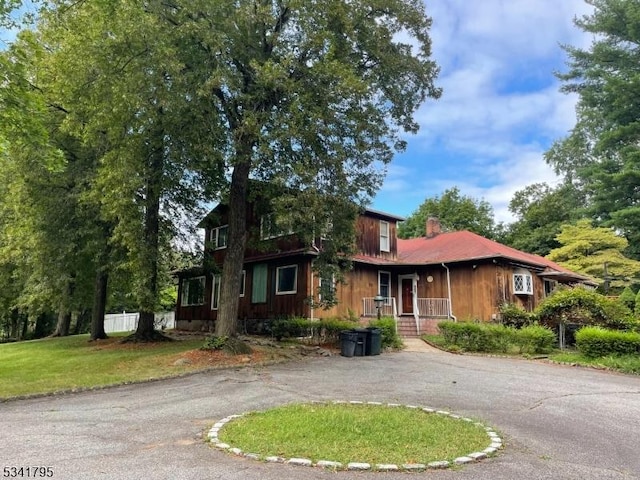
[372,0,592,222]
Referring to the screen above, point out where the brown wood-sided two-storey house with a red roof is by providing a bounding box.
[176,197,595,336]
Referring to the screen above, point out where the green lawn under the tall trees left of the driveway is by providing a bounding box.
[0,334,202,399]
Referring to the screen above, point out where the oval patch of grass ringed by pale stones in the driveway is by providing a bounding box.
[219,404,491,465]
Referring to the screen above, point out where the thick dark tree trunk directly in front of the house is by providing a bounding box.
[215,159,253,336]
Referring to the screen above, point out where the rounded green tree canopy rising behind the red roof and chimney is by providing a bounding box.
[398,187,496,239]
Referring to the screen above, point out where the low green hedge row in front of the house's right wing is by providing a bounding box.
[438,321,556,354]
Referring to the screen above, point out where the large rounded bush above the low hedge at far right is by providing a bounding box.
[536,287,636,329]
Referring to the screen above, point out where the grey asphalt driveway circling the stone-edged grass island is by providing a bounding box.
[0,351,640,480]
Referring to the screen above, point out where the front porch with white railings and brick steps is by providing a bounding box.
[361,297,451,337]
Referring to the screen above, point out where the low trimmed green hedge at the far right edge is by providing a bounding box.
[576,327,640,358]
